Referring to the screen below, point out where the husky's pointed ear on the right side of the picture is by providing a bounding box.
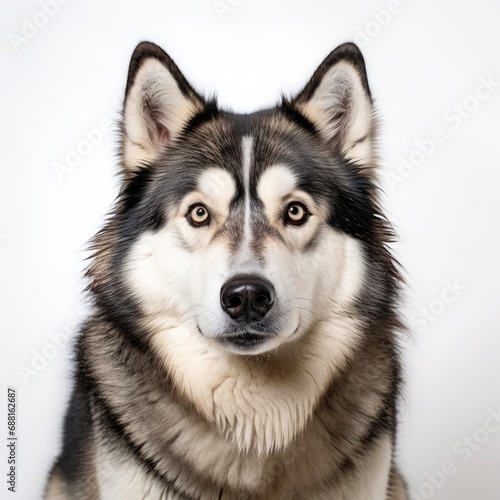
[292,43,375,165]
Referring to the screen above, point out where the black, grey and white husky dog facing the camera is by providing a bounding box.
[46,43,407,500]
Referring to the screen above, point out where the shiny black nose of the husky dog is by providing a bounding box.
[220,275,274,323]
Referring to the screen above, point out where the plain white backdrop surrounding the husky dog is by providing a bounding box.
[0,0,500,500]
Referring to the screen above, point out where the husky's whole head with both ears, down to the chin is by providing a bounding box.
[91,43,390,354]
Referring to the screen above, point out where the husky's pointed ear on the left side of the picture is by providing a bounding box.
[122,42,204,174]
